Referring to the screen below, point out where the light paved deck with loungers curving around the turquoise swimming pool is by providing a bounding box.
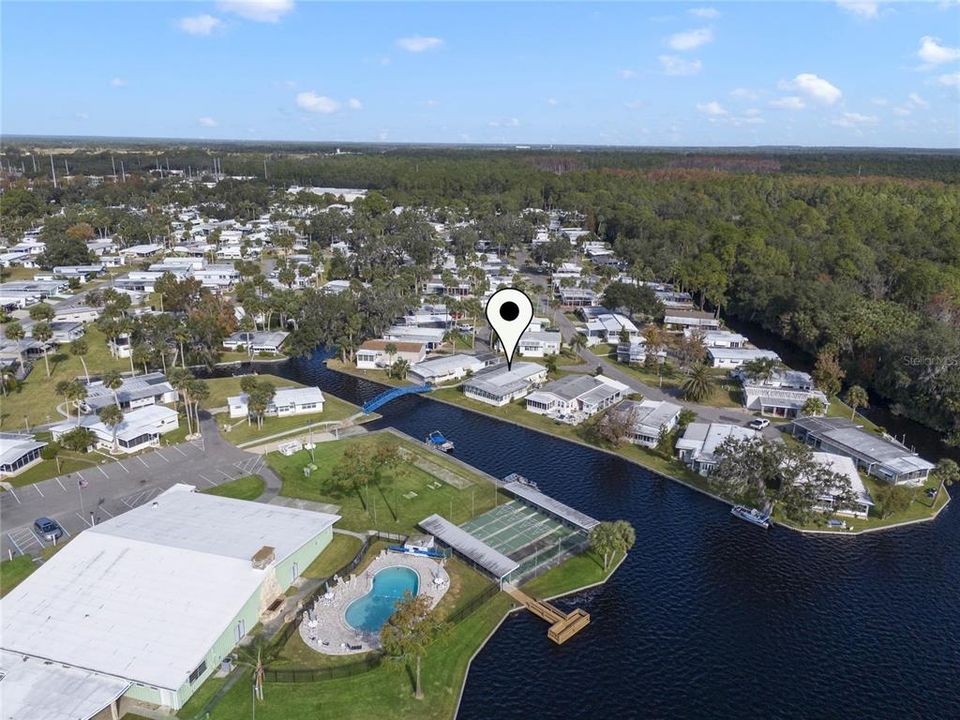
[300,550,450,655]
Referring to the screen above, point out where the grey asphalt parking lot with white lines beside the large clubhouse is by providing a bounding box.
[0,430,263,559]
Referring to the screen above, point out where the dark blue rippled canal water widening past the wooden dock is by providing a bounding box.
[202,353,960,720]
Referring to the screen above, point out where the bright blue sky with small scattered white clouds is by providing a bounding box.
[0,0,960,148]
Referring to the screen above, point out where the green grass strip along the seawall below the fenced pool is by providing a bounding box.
[197,593,513,720]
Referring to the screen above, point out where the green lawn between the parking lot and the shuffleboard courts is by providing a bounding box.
[266,433,506,533]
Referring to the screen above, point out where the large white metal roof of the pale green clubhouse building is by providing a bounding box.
[0,485,339,690]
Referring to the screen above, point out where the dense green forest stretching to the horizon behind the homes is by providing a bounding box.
[3,140,960,442]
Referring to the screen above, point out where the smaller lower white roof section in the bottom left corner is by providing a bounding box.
[0,650,130,720]
